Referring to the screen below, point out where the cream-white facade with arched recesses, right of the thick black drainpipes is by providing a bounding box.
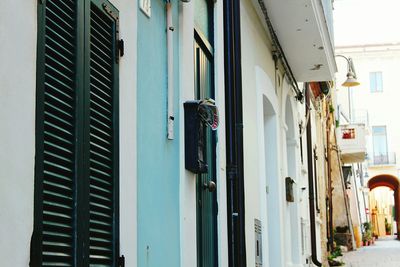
[241,1,308,267]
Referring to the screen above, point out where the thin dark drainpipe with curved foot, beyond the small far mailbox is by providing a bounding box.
[305,86,322,267]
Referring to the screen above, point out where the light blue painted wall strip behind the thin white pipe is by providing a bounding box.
[137,0,180,267]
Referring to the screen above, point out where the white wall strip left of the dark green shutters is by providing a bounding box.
[0,0,37,267]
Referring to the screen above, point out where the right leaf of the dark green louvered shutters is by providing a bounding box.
[89,1,118,266]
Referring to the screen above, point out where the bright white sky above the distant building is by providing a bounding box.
[333,0,400,47]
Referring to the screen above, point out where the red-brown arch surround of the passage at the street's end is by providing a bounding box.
[368,174,400,239]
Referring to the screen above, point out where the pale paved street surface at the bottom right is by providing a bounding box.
[343,238,400,267]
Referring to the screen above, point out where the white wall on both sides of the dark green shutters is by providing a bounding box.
[0,0,137,267]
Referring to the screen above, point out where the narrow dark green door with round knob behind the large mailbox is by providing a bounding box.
[194,27,218,267]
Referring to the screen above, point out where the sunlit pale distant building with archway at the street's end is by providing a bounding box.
[336,43,400,241]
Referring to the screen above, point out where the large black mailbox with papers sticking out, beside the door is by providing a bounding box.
[183,99,219,173]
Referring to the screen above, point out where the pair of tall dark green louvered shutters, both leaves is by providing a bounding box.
[34,0,119,266]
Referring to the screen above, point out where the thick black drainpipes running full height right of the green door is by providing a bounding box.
[224,1,246,267]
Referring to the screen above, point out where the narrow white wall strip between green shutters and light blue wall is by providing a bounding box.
[115,0,138,266]
